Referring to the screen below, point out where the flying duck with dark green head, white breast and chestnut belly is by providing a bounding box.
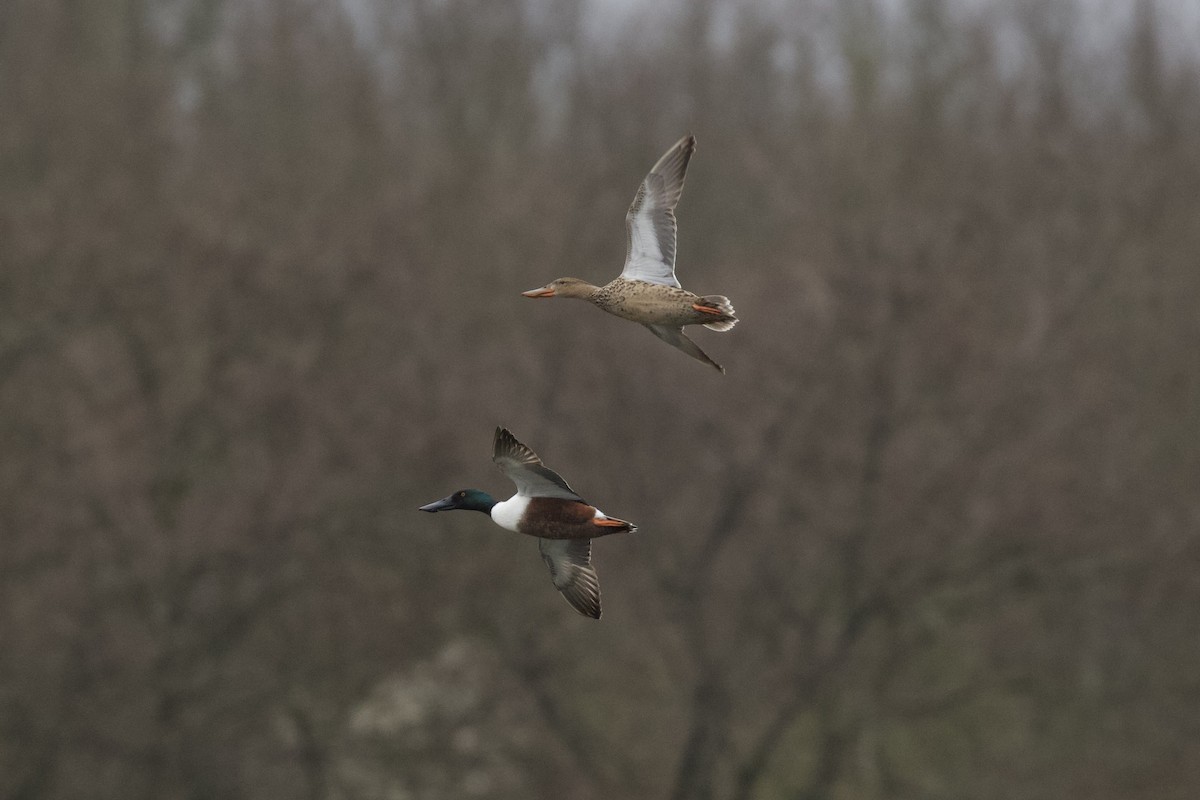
[420,428,637,619]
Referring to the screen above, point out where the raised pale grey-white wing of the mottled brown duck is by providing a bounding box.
[620,136,696,287]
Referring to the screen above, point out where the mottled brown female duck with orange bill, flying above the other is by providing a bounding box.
[522,136,738,372]
